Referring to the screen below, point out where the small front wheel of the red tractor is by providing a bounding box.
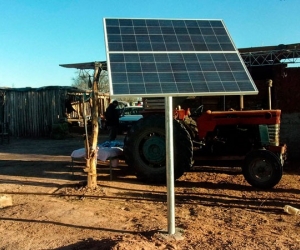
[242,150,282,189]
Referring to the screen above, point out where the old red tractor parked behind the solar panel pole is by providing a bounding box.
[124,96,286,189]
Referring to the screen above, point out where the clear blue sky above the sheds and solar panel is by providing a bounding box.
[0,0,300,88]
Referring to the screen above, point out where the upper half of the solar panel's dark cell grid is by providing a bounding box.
[106,19,234,51]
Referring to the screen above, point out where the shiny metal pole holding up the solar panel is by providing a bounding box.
[165,96,175,234]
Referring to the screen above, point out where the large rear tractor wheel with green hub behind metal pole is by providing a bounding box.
[124,115,193,183]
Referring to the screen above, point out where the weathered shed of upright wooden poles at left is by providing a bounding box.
[0,86,109,137]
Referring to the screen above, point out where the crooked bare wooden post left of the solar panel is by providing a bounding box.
[87,65,101,189]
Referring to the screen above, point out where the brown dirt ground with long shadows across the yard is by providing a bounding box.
[0,132,300,250]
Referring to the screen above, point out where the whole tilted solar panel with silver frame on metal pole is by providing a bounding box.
[104,18,258,97]
